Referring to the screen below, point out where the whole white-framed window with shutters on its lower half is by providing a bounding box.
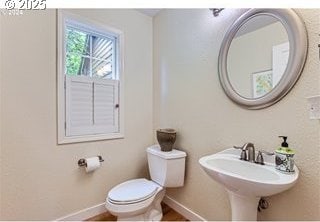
[58,10,123,143]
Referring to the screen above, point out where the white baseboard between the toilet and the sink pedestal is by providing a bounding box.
[163,195,207,221]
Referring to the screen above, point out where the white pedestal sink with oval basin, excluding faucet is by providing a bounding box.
[199,148,299,221]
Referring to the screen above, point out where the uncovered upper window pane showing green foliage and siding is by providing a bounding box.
[65,26,115,79]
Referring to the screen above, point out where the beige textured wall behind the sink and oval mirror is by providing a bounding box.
[153,9,320,220]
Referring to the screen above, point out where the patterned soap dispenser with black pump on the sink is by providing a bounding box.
[275,136,295,173]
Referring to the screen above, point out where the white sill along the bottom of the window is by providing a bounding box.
[58,133,124,145]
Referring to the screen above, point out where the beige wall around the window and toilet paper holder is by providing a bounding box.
[0,10,153,220]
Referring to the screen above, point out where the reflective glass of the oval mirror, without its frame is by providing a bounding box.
[227,15,290,98]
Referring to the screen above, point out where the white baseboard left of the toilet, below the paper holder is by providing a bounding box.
[55,203,107,221]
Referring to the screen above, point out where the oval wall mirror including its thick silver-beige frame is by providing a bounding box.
[219,9,307,109]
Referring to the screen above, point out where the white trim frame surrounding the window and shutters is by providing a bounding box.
[56,9,124,144]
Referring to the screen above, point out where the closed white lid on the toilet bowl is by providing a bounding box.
[108,178,159,203]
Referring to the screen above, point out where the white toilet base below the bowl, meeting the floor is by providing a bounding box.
[115,189,165,221]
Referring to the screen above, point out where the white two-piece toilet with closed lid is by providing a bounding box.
[106,145,187,221]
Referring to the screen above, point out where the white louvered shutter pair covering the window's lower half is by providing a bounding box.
[66,76,119,136]
